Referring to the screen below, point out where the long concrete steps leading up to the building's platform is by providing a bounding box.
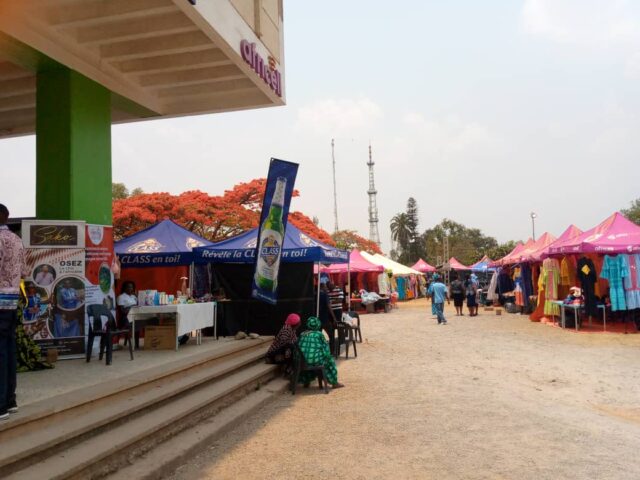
[0,339,277,479]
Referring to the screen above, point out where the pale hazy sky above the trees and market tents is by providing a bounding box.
[0,0,640,251]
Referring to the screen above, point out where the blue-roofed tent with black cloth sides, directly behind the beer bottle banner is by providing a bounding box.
[193,227,349,334]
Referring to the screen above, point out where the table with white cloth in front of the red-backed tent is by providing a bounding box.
[127,302,217,350]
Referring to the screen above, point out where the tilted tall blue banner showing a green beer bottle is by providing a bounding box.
[251,158,298,305]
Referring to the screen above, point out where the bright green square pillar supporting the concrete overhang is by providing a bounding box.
[36,67,111,225]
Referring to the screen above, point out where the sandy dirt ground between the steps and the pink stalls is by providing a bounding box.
[171,300,640,480]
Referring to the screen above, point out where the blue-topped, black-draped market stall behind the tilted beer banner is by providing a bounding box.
[194,224,349,335]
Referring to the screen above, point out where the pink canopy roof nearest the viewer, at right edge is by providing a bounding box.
[548,212,640,255]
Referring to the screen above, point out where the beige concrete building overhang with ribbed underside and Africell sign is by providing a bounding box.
[0,0,285,137]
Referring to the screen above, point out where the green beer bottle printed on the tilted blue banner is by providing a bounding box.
[254,177,287,295]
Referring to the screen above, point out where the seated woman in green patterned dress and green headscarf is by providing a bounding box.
[298,317,344,388]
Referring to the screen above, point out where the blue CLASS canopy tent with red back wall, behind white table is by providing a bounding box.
[114,220,211,293]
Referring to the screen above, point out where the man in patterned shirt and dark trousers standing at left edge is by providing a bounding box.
[0,204,28,420]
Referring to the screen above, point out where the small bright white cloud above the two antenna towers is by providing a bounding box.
[296,97,383,136]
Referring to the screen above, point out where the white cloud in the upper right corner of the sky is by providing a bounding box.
[522,0,640,47]
